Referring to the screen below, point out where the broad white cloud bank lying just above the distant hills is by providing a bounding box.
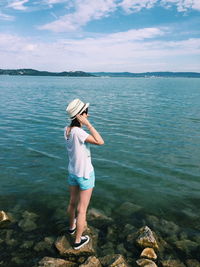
[0,28,200,72]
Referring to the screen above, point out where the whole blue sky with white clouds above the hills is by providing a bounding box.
[0,0,200,73]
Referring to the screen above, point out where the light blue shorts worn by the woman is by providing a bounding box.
[68,171,95,190]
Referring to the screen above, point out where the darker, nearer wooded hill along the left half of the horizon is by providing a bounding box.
[0,69,94,77]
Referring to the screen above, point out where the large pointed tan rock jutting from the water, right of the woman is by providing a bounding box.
[136,226,158,249]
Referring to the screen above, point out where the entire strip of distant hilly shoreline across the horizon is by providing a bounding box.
[0,69,200,78]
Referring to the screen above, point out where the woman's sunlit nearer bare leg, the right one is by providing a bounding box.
[75,188,93,243]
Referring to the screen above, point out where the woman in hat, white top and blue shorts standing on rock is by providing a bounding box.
[64,99,104,249]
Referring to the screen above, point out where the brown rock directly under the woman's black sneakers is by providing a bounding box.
[55,236,95,260]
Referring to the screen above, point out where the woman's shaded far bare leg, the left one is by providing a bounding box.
[67,186,80,229]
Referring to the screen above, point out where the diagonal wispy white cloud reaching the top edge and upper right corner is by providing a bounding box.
[39,0,200,32]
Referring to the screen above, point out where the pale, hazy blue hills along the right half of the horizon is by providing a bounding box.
[91,72,200,78]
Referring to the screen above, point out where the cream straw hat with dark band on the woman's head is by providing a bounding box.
[66,98,89,120]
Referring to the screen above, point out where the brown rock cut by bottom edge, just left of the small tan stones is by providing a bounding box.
[100,254,128,267]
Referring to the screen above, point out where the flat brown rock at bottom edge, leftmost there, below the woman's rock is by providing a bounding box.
[38,257,77,267]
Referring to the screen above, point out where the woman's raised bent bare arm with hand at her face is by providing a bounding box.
[76,115,104,145]
